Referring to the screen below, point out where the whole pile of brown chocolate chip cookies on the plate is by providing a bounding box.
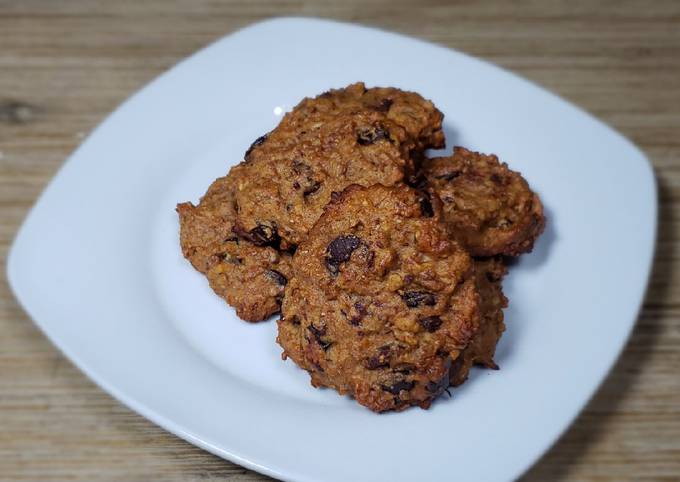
[177,83,545,412]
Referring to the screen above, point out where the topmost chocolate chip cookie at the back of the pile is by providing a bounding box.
[236,83,444,248]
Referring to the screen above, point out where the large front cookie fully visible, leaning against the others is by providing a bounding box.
[277,185,480,412]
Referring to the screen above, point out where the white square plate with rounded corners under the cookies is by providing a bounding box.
[3,19,656,481]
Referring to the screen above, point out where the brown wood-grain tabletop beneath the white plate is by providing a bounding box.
[0,0,680,481]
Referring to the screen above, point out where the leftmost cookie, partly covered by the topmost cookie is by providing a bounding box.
[177,177,291,321]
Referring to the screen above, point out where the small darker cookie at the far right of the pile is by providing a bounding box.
[423,147,545,256]
